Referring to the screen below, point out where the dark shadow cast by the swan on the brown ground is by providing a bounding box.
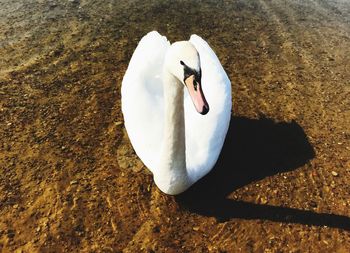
[176,117,350,230]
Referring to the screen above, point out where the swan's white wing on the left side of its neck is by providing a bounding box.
[121,31,170,169]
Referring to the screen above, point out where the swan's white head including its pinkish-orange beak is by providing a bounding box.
[165,41,209,115]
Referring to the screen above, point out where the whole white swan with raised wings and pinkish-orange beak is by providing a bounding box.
[121,31,232,195]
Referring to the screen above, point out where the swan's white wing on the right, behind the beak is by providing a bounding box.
[185,35,232,180]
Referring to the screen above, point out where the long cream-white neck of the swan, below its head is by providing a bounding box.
[154,69,191,195]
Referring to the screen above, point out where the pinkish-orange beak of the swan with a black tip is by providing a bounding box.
[185,75,209,115]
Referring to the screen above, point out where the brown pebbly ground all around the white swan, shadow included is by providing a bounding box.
[0,0,350,253]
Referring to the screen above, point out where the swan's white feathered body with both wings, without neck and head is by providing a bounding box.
[122,32,232,182]
